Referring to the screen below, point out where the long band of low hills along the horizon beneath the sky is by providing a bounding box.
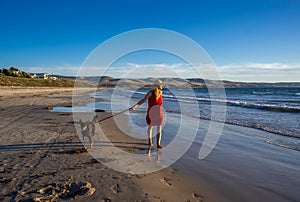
[0,67,300,88]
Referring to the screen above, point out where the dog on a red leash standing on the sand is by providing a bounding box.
[79,115,98,149]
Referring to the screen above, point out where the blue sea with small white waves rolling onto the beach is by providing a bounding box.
[89,88,300,151]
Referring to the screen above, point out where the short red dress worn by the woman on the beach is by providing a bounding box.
[146,91,164,126]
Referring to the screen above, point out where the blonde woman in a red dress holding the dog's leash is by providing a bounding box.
[130,79,164,148]
